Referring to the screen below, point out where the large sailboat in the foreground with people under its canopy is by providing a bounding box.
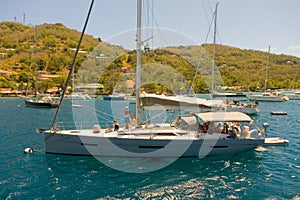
[41,0,267,158]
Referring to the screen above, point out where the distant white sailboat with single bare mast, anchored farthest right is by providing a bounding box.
[249,46,289,102]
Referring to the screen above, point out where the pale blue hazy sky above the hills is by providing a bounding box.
[0,0,300,57]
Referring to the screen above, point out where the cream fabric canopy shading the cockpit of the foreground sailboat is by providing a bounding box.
[196,112,252,122]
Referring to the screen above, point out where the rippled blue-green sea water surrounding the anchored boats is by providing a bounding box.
[0,98,300,199]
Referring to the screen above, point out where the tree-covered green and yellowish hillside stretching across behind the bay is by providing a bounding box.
[0,22,300,94]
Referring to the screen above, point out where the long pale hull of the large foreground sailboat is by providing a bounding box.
[45,130,264,157]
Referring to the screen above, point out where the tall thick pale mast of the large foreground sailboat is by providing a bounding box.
[135,0,142,126]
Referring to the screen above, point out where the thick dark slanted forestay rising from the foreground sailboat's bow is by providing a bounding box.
[51,0,94,130]
